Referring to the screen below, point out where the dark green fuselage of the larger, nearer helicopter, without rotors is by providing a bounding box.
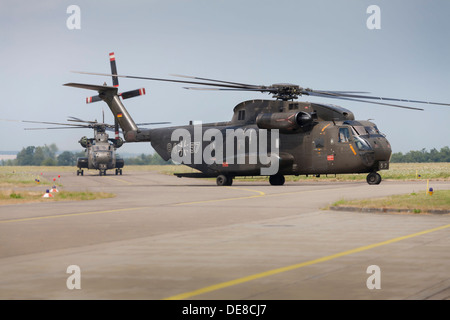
[124,100,391,184]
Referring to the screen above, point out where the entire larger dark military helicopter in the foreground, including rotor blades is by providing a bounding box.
[64,52,450,186]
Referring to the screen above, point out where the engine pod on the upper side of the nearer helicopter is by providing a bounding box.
[256,111,315,133]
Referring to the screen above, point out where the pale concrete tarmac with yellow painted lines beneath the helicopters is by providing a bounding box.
[0,167,450,300]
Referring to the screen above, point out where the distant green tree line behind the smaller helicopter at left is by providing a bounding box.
[0,144,172,166]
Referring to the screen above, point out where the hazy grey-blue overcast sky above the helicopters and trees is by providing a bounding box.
[0,0,450,153]
